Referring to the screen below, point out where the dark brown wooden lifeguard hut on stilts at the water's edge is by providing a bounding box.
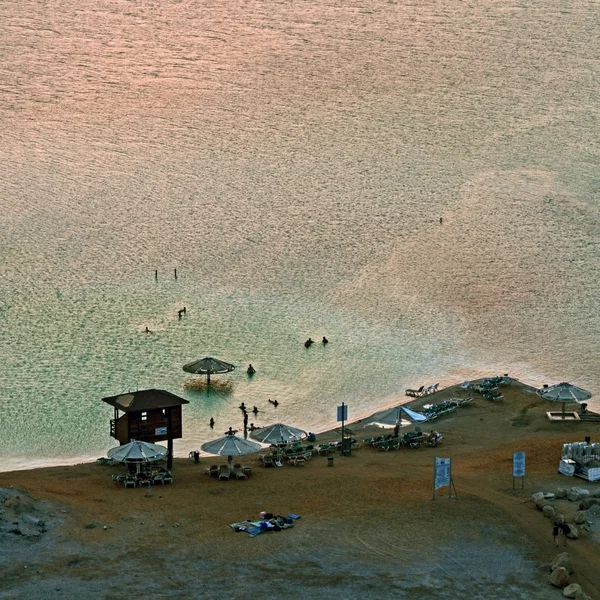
[102,390,189,468]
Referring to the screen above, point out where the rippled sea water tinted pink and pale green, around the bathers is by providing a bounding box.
[0,0,600,469]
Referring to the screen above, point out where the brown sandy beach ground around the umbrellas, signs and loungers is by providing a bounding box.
[0,382,600,600]
